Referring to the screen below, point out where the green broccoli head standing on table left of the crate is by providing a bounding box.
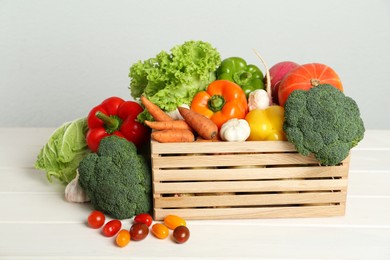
[78,135,152,219]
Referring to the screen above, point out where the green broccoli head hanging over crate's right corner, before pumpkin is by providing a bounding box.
[283,84,365,165]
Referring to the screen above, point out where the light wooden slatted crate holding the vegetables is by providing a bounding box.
[151,141,349,220]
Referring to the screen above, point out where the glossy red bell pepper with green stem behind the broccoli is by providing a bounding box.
[86,97,150,152]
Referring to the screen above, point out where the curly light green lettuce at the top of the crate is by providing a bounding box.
[129,41,221,122]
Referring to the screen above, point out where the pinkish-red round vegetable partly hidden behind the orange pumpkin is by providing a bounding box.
[269,61,299,104]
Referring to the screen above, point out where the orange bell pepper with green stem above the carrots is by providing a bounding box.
[191,80,248,129]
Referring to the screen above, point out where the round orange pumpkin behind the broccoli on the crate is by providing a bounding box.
[278,63,343,106]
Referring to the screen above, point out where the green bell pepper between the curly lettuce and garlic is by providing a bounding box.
[216,57,264,97]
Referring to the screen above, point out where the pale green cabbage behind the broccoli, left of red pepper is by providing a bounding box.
[34,118,90,183]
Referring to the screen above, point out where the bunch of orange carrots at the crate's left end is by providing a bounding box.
[141,96,218,143]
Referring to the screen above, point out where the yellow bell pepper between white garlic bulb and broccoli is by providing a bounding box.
[245,105,287,141]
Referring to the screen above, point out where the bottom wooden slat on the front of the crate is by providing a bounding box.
[154,204,345,220]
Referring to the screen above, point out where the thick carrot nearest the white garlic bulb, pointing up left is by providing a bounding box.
[178,107,218,140]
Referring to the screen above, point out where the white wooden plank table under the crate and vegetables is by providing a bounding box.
[0,128,390,260]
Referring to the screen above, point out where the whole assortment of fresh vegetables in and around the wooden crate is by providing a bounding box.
[35,38,365,247]
